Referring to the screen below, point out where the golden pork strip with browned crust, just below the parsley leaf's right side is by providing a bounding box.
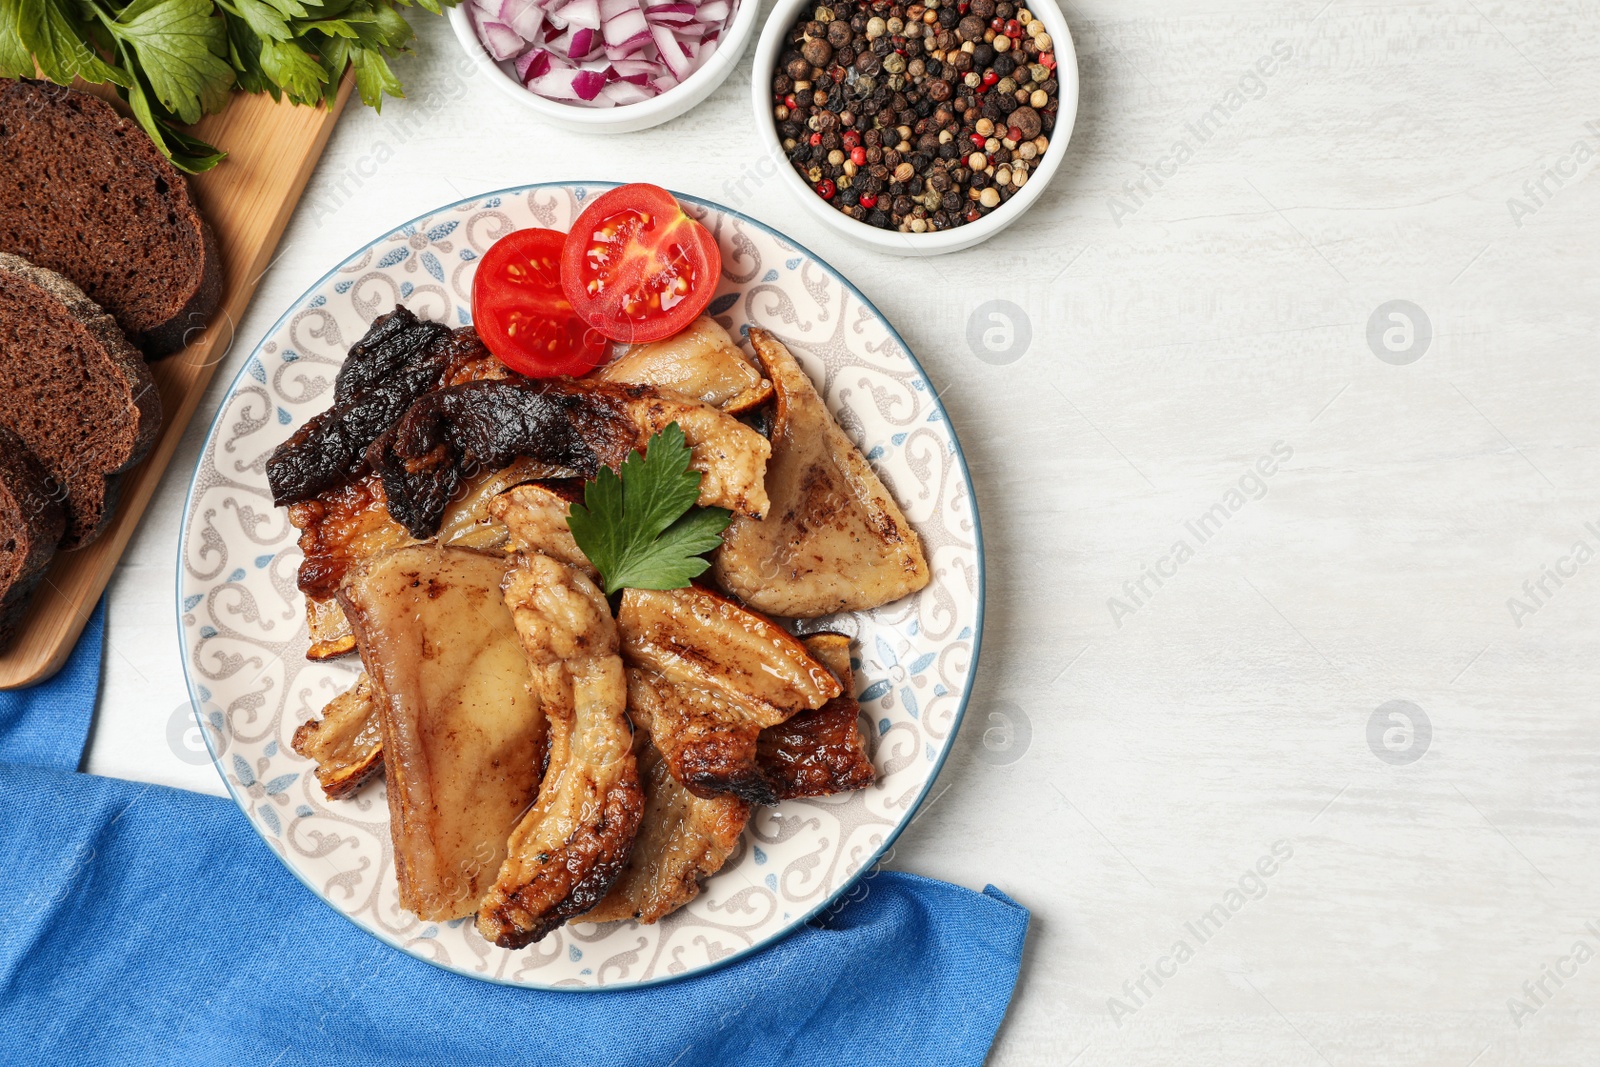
[618,587,843,803]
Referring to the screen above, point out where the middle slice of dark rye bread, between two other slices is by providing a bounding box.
[0,253,162,549]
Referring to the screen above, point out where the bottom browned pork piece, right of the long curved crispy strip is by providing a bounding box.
[582,735,750,923]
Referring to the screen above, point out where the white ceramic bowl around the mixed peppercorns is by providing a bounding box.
[750,0,1078,256]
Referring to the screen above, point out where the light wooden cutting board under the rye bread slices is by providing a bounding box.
[0,77,354,689]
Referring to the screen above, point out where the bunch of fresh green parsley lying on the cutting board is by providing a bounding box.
[0,0,454,173]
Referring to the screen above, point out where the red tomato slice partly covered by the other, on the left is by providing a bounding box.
[472,230,611,378]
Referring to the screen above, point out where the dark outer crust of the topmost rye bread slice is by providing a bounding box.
[0,78,222,357]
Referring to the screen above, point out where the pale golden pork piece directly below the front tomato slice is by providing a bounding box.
[592,315,773,414]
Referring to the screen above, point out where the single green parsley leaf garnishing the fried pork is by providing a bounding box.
[566,422,733,593]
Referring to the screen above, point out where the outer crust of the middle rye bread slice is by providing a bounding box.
[0,253,162,550]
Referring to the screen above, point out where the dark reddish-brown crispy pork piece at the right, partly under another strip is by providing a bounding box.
[755,633,877,800]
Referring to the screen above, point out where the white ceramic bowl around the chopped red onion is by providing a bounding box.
[450,0,762,133]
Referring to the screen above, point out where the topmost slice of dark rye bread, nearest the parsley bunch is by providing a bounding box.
[0,80,222,355]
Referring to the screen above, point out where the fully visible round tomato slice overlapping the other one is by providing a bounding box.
[562,184,722,342]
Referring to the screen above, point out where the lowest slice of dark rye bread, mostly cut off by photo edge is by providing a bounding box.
[0,426,67,649]
